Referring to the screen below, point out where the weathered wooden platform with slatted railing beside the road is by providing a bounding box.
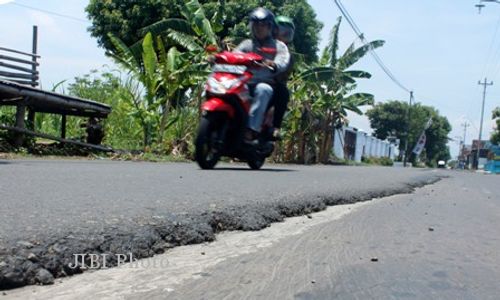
[0,26,111,151]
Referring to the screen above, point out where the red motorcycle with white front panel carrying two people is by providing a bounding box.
[195,52,274,170]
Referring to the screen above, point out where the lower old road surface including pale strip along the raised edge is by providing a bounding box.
[5,168,500,299]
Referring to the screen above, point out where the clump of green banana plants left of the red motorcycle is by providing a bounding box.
[105,0,223,152]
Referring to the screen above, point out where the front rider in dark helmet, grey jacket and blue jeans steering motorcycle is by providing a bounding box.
[234,7,290,141]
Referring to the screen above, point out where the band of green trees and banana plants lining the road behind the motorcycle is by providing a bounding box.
[0,0,449,165]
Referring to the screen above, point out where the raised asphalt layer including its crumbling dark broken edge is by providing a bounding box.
[0,160,445,290]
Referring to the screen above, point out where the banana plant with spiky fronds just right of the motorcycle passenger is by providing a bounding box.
[292,17,384,163]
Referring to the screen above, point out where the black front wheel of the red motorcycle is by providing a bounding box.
[195,115,220,170]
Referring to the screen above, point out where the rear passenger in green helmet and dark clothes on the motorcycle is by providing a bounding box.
[271,16,295,139]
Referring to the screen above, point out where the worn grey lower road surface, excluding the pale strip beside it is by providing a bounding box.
[161,170,500,299]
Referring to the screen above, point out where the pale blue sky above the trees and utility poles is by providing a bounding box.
[0,0,500,157]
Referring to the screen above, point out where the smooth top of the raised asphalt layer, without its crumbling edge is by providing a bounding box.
[0,160,435,242]
